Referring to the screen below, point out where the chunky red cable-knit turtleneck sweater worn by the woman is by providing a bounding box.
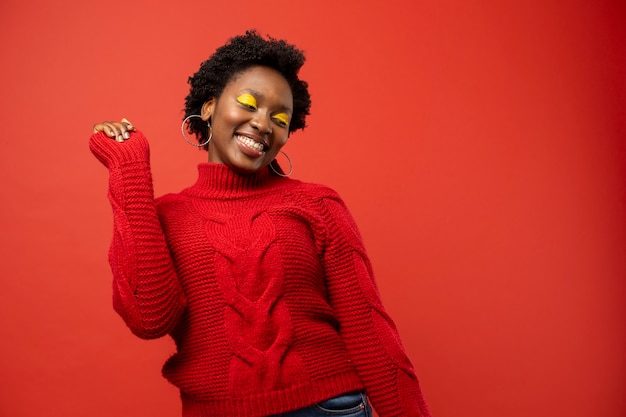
[90,132,429,417]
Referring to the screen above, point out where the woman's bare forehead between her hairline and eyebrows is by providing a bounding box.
[224,66,293,107]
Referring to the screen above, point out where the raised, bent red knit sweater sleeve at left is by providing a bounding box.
[89,132,185,339]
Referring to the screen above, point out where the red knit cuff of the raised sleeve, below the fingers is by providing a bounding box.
[89,131,150,168]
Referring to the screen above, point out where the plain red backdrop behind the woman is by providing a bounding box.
[0,0,626,417]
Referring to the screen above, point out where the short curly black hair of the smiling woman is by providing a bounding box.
[184,30,311,149]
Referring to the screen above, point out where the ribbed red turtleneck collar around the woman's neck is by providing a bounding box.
[184,162,288,199]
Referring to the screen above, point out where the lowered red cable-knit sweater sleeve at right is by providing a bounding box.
[323,192,430,417]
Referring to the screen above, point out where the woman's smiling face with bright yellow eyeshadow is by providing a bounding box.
[202,66,293,173]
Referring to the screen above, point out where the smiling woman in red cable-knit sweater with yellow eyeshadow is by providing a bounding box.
[90,31,429,417]
